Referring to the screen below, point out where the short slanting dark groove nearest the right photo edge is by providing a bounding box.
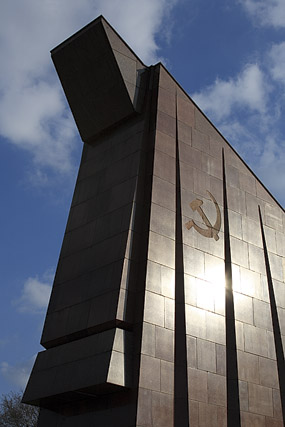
[258,206,285,422]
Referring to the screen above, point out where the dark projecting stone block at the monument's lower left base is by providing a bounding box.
[23,329,132,407]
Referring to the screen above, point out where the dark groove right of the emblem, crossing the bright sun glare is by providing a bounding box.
[222,150,241,427]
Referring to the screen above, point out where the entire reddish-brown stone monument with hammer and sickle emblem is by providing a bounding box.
[24,17,285,427]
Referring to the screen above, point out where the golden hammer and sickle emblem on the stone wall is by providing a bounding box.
[185,191,221,241]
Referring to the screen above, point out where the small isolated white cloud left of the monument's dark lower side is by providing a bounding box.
[13,272,53,313]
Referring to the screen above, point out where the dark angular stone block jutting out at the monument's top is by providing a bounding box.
[51,17,146,142]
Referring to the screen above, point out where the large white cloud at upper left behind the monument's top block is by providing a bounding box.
[0,0,176,177]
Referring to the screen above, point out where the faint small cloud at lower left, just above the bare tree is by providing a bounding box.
[0,355,36,389]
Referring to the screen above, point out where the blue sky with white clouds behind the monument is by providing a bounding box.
[0,0,285,394]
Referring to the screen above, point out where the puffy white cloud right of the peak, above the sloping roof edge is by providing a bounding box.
[192,64,268,120]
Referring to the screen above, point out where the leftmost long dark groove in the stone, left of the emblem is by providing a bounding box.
[174,95,189,427]
